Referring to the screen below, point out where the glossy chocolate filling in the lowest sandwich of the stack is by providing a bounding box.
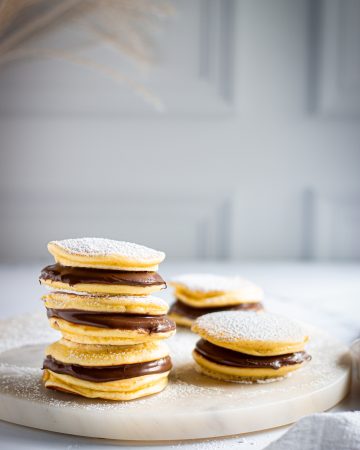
[43,355,172,383]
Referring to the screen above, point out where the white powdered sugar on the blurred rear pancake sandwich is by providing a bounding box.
[171,273,256,292]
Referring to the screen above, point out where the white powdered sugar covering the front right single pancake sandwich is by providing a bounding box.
[195,311,306,342]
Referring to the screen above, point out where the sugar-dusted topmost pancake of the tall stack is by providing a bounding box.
[48,238,165,271]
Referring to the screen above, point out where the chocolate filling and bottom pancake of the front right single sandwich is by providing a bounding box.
[193,339,311,382]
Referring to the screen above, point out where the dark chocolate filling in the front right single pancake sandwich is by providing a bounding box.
[195,339,311,370]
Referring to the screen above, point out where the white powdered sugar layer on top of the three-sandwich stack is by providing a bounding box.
[49,238,165,262]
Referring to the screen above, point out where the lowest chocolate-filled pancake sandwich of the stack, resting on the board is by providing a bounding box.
[43,339,171,400]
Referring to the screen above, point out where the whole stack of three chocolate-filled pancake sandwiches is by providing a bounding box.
[40,238,176,400]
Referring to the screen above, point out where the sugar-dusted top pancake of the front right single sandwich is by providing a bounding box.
[192,311,308,356]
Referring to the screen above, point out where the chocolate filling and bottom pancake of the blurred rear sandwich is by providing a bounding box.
[169,300,264,327]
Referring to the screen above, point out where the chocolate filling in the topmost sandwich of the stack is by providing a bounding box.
[40,264,166,287]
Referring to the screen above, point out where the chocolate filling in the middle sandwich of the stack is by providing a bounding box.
[47,308,176,334]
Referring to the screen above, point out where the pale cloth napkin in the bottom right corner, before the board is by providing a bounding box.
[266,412,360,450]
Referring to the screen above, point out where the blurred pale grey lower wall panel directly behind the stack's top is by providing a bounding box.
[0,194,235,262]
